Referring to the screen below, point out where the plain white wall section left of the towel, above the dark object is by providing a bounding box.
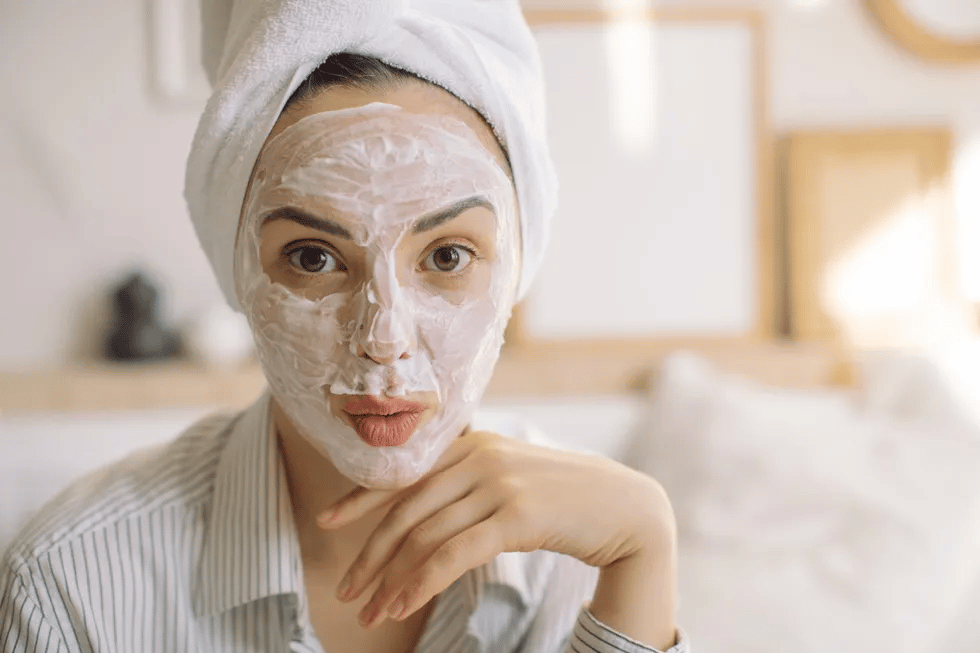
[0,0,219,369]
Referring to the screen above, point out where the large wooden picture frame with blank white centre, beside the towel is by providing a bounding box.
[508,9,780,347]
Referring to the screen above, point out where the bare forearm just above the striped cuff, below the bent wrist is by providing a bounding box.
[589,529,677,651]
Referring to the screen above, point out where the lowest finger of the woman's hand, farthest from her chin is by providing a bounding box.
[369,513,507,623]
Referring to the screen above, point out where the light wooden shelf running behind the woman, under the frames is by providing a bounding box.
[0,339,849,415]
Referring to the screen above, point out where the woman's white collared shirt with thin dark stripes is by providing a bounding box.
[0,395,688,653]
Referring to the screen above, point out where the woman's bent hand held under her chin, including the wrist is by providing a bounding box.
[318,432,674,633]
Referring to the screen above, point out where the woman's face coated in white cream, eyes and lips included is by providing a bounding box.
[236,83,519,487]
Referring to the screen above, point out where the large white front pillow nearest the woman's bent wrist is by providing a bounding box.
[631,353,980,653]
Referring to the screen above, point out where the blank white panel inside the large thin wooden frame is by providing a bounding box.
[523,23,759,339]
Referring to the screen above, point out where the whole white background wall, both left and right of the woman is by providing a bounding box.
[0,0,980,369]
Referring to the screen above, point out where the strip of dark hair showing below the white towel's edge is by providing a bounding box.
[283,52,425,111]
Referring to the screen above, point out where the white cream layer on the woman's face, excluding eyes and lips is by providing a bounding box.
[235,103,519,488]
